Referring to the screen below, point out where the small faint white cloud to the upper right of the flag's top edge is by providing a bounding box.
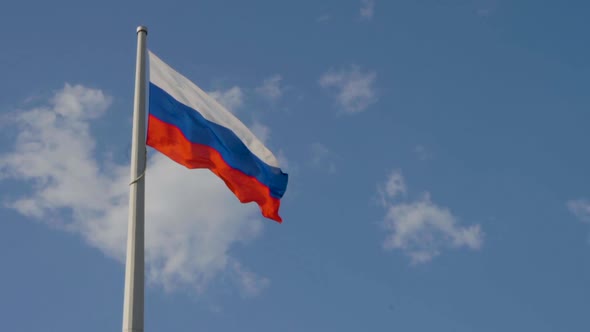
[319,66,377,113]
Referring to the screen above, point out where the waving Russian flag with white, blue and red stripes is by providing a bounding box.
[146,52,288,222]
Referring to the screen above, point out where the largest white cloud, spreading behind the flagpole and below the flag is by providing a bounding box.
[0,85,268,294]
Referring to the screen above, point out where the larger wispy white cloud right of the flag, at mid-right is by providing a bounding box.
[381,171,483,264]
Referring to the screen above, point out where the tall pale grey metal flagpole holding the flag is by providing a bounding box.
[123,26,147,332]
